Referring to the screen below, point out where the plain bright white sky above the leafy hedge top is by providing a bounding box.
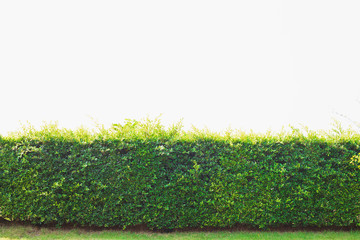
[0,0,360,134]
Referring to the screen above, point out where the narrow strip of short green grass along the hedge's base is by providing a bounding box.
[0,225,360,240]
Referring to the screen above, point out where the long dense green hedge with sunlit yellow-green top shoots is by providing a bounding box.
[0,120,360,229]
